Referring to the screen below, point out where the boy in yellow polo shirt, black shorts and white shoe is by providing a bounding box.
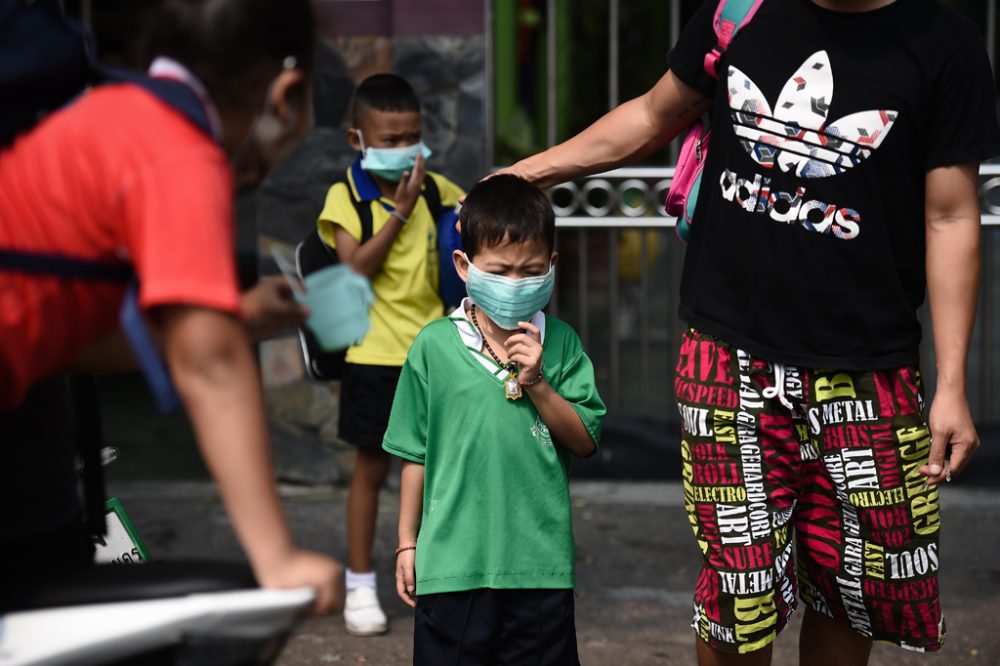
[317,74,463,636]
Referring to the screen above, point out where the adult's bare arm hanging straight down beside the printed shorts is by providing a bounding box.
[921,162,980,483]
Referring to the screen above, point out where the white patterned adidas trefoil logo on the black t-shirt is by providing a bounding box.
[728,51,898,178]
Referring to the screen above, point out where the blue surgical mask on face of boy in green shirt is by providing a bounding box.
[465,256,556,331]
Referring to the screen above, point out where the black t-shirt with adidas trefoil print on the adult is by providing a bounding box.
[669,0,1000,370]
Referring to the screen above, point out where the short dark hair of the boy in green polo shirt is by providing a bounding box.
[458,174,556,258]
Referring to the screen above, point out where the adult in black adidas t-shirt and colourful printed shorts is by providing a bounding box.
[507,0,1000,664]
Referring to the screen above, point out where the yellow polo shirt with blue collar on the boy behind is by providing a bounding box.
[316,161,463,366]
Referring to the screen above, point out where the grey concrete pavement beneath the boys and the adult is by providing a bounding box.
[109,478,1000,666]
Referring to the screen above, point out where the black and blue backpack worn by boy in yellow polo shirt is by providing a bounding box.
[295,175,465,382]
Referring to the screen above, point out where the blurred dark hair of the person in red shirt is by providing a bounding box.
[152,0,316,110]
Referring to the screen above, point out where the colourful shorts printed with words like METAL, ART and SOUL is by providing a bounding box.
[675,330,944,652]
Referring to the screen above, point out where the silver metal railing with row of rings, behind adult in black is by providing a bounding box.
[550,164,1000,422]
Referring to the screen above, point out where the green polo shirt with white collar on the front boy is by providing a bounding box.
[383,308,605,594]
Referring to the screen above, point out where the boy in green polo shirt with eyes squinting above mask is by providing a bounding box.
[382,176,605,666]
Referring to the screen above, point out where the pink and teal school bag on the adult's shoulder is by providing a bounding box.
[665,0,764,241]
